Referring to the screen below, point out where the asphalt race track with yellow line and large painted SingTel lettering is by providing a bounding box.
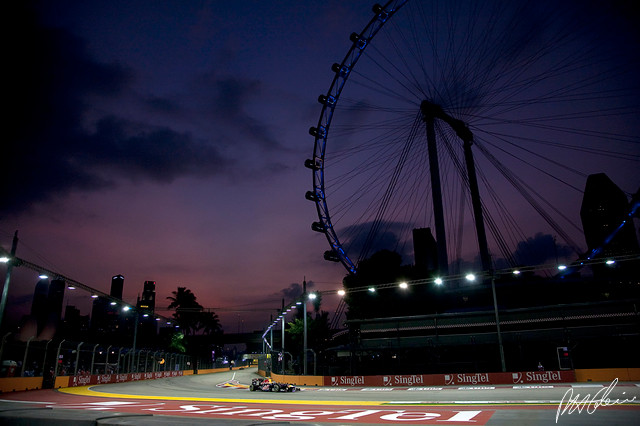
[0,369,640,426]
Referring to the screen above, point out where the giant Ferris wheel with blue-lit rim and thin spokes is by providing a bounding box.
[305,0,640,274]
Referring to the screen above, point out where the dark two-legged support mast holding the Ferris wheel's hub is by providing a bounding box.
[420,100,493,273]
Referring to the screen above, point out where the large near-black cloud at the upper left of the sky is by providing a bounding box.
[0,6,232,213]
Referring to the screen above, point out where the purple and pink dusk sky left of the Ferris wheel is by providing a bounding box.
[0,0,640,332]
